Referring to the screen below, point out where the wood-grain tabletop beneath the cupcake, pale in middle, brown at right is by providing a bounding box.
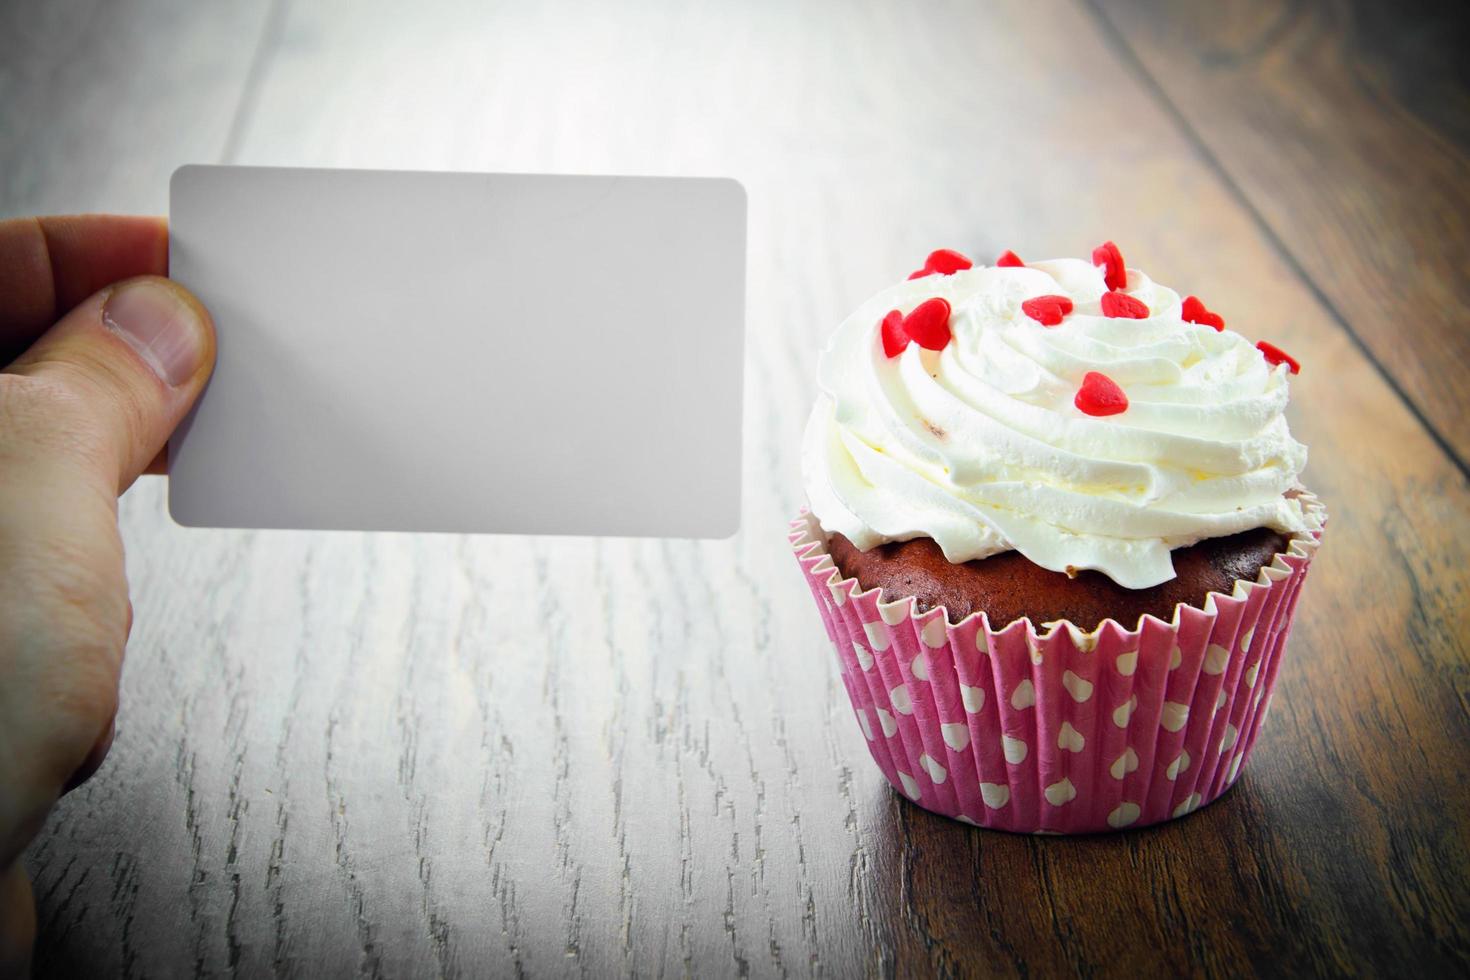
[0,0,1470,977]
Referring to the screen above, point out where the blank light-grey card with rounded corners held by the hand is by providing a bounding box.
[169,166,745,538]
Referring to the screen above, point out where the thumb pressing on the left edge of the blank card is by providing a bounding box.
[0,276,215,494]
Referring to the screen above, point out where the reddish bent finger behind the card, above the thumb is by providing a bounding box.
[0,215,169,366]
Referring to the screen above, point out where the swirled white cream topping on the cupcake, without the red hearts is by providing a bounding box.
[801,259,1314,589]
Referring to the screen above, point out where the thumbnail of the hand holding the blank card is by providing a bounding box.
[101,279,204,388]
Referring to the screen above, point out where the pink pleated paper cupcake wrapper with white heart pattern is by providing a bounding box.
[791,495,1324,833]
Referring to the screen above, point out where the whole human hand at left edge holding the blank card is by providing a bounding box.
[0,215,215,976]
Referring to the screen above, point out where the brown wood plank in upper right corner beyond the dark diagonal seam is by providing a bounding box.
[1094,0,1470,469]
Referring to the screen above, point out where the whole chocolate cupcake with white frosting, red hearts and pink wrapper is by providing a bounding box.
[791,242,1326,833]
